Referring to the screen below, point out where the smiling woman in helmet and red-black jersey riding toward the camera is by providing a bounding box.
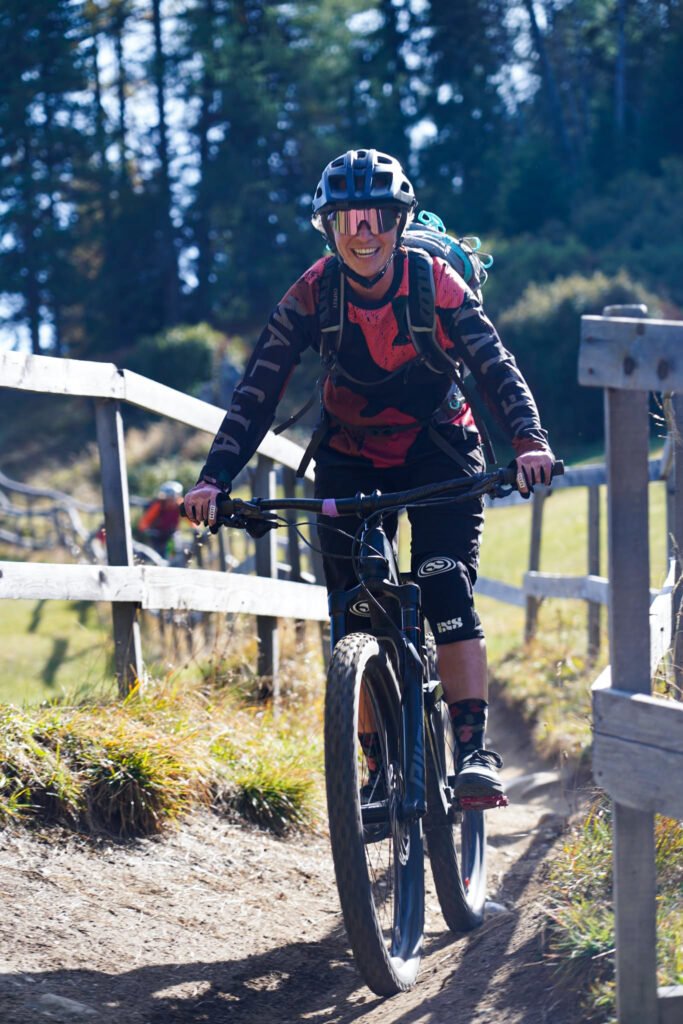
[184,150,553,808]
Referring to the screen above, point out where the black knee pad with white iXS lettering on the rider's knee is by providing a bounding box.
[414,555,484,644]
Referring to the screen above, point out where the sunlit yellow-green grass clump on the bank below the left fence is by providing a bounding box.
[0,679,322,838]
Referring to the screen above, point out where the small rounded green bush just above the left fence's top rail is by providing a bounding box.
[127,324,225,394]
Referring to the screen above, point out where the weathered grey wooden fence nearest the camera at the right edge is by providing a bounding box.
[579,310,683,1024]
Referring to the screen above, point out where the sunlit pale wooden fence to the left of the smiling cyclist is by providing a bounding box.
[0,352,328,692]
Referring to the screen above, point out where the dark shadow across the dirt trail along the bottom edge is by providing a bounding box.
[0,834,579,1024]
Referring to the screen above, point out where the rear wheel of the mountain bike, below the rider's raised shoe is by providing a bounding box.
[424,636,486,932]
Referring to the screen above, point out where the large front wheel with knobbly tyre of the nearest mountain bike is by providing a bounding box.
[325,633,424,995]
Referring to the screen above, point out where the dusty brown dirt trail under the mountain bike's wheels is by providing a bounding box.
[0,710,585,1024]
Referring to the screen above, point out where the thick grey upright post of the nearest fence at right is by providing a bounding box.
[605,366,657,1024]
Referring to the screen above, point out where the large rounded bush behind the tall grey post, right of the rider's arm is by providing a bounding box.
[498,271,661,449]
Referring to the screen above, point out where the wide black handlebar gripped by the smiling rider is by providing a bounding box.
[180,461,564,527]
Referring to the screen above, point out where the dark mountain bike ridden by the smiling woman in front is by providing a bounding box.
[189,463,564,995]
